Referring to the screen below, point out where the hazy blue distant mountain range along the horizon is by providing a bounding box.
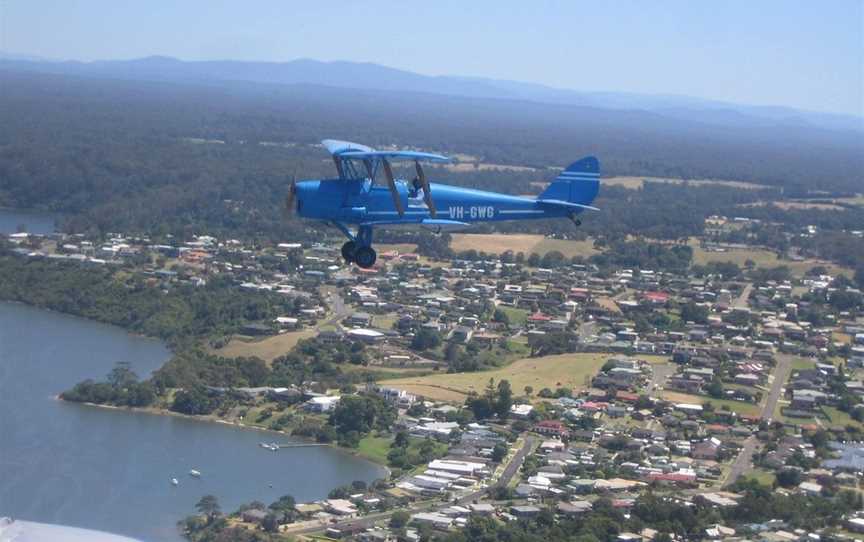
[0,53,864,132]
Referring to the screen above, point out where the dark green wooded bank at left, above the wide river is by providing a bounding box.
[0,253,288,348]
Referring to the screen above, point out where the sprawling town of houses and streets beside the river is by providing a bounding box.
[7,218,864,542]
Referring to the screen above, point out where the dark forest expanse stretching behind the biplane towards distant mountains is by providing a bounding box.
[0,71,864,237]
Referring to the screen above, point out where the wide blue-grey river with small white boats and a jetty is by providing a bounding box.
[0,302,383,541]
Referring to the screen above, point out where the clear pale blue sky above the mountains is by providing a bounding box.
[0,0,864,115]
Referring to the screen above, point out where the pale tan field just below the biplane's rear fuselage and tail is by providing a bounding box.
[450,233,599,258]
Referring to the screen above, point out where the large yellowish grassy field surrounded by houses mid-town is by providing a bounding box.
[382,354,609,403]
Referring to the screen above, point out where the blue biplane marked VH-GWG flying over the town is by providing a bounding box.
[285,139,600,268]
